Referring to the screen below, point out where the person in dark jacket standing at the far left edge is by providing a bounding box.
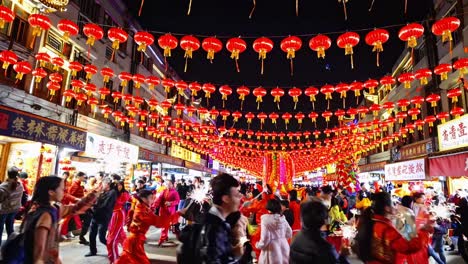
[0,167,24,245]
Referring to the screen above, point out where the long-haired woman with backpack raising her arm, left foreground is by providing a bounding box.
[23,176,97,263]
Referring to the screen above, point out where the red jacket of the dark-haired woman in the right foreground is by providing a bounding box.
[367,215,429,264]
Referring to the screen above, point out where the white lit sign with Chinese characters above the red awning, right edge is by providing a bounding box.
[437,114,468,151]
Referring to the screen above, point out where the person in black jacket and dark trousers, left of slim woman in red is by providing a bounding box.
[85,178,117,257]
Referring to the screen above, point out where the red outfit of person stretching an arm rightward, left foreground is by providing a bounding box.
[115,201,180,264]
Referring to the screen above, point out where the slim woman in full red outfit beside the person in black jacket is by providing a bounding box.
[106,180,131,263]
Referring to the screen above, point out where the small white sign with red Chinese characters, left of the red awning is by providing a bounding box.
[385,159,426,181]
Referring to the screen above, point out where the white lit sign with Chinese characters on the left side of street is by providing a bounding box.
[86,133,138,163]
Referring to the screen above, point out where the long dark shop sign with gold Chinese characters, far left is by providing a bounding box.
[0,107,86,151]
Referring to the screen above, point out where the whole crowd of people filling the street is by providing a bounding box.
[0,168,468,264]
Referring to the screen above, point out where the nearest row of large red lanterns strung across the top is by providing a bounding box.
[11,10,460,74]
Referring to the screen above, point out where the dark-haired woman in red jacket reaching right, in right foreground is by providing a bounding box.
[355,192,429,264]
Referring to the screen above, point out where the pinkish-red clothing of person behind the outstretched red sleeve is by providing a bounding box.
[152,188,180,244]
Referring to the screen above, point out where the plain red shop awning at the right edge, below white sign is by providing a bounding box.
[429,152,468,177]
